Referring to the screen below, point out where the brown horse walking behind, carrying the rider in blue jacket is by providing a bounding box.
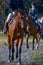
[24,14,40,50]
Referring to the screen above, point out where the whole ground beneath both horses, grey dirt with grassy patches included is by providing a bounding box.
[0,38,43,65]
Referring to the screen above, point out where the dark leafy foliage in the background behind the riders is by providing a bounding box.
[0,0,43,29]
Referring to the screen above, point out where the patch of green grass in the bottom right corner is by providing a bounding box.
[29,53,43,65]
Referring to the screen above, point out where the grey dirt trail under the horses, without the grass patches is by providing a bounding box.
[0,41,43,65]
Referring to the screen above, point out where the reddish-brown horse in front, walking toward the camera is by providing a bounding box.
[7,12,24,64]
